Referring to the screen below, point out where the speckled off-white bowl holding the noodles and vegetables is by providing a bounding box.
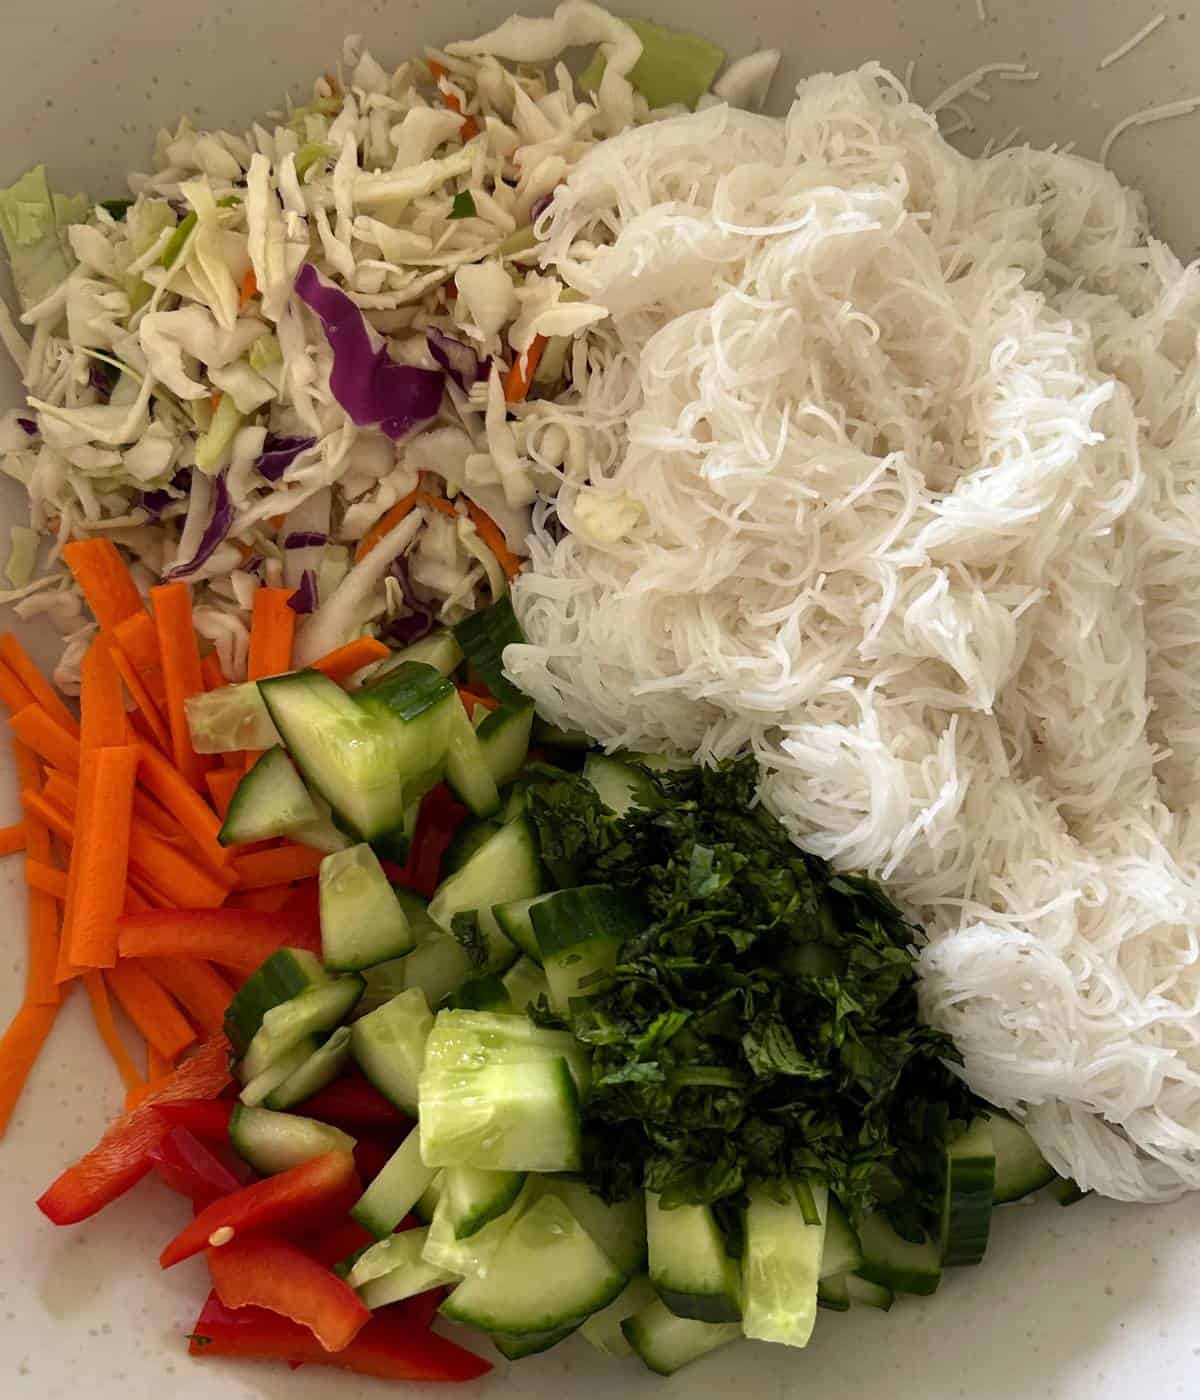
[0,0,1200,1400]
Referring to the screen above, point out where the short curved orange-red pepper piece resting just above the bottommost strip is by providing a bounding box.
[207,1235,371,1351]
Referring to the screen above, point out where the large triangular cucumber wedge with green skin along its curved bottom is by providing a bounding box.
[441,1196,625,1337]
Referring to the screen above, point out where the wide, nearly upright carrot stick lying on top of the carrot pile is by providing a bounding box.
[67,745,137,967]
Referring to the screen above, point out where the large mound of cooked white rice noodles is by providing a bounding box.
[505,64,1200,1200]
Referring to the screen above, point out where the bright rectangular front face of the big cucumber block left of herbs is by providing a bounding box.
[420,1060,582,1172]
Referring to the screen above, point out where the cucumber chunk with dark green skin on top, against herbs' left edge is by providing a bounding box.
[529,885,646,1019]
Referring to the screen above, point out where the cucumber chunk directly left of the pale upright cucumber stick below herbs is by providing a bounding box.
[646,1191,742,1322]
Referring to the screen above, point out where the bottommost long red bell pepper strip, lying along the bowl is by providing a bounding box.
[188,1294,491,1380]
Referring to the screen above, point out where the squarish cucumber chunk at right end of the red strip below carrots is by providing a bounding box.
[321,844,416,972]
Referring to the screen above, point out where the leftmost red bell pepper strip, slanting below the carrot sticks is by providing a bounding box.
[38,1036,230,1225]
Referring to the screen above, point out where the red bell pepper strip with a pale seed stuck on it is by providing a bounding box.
[158,1152,363,1268]
